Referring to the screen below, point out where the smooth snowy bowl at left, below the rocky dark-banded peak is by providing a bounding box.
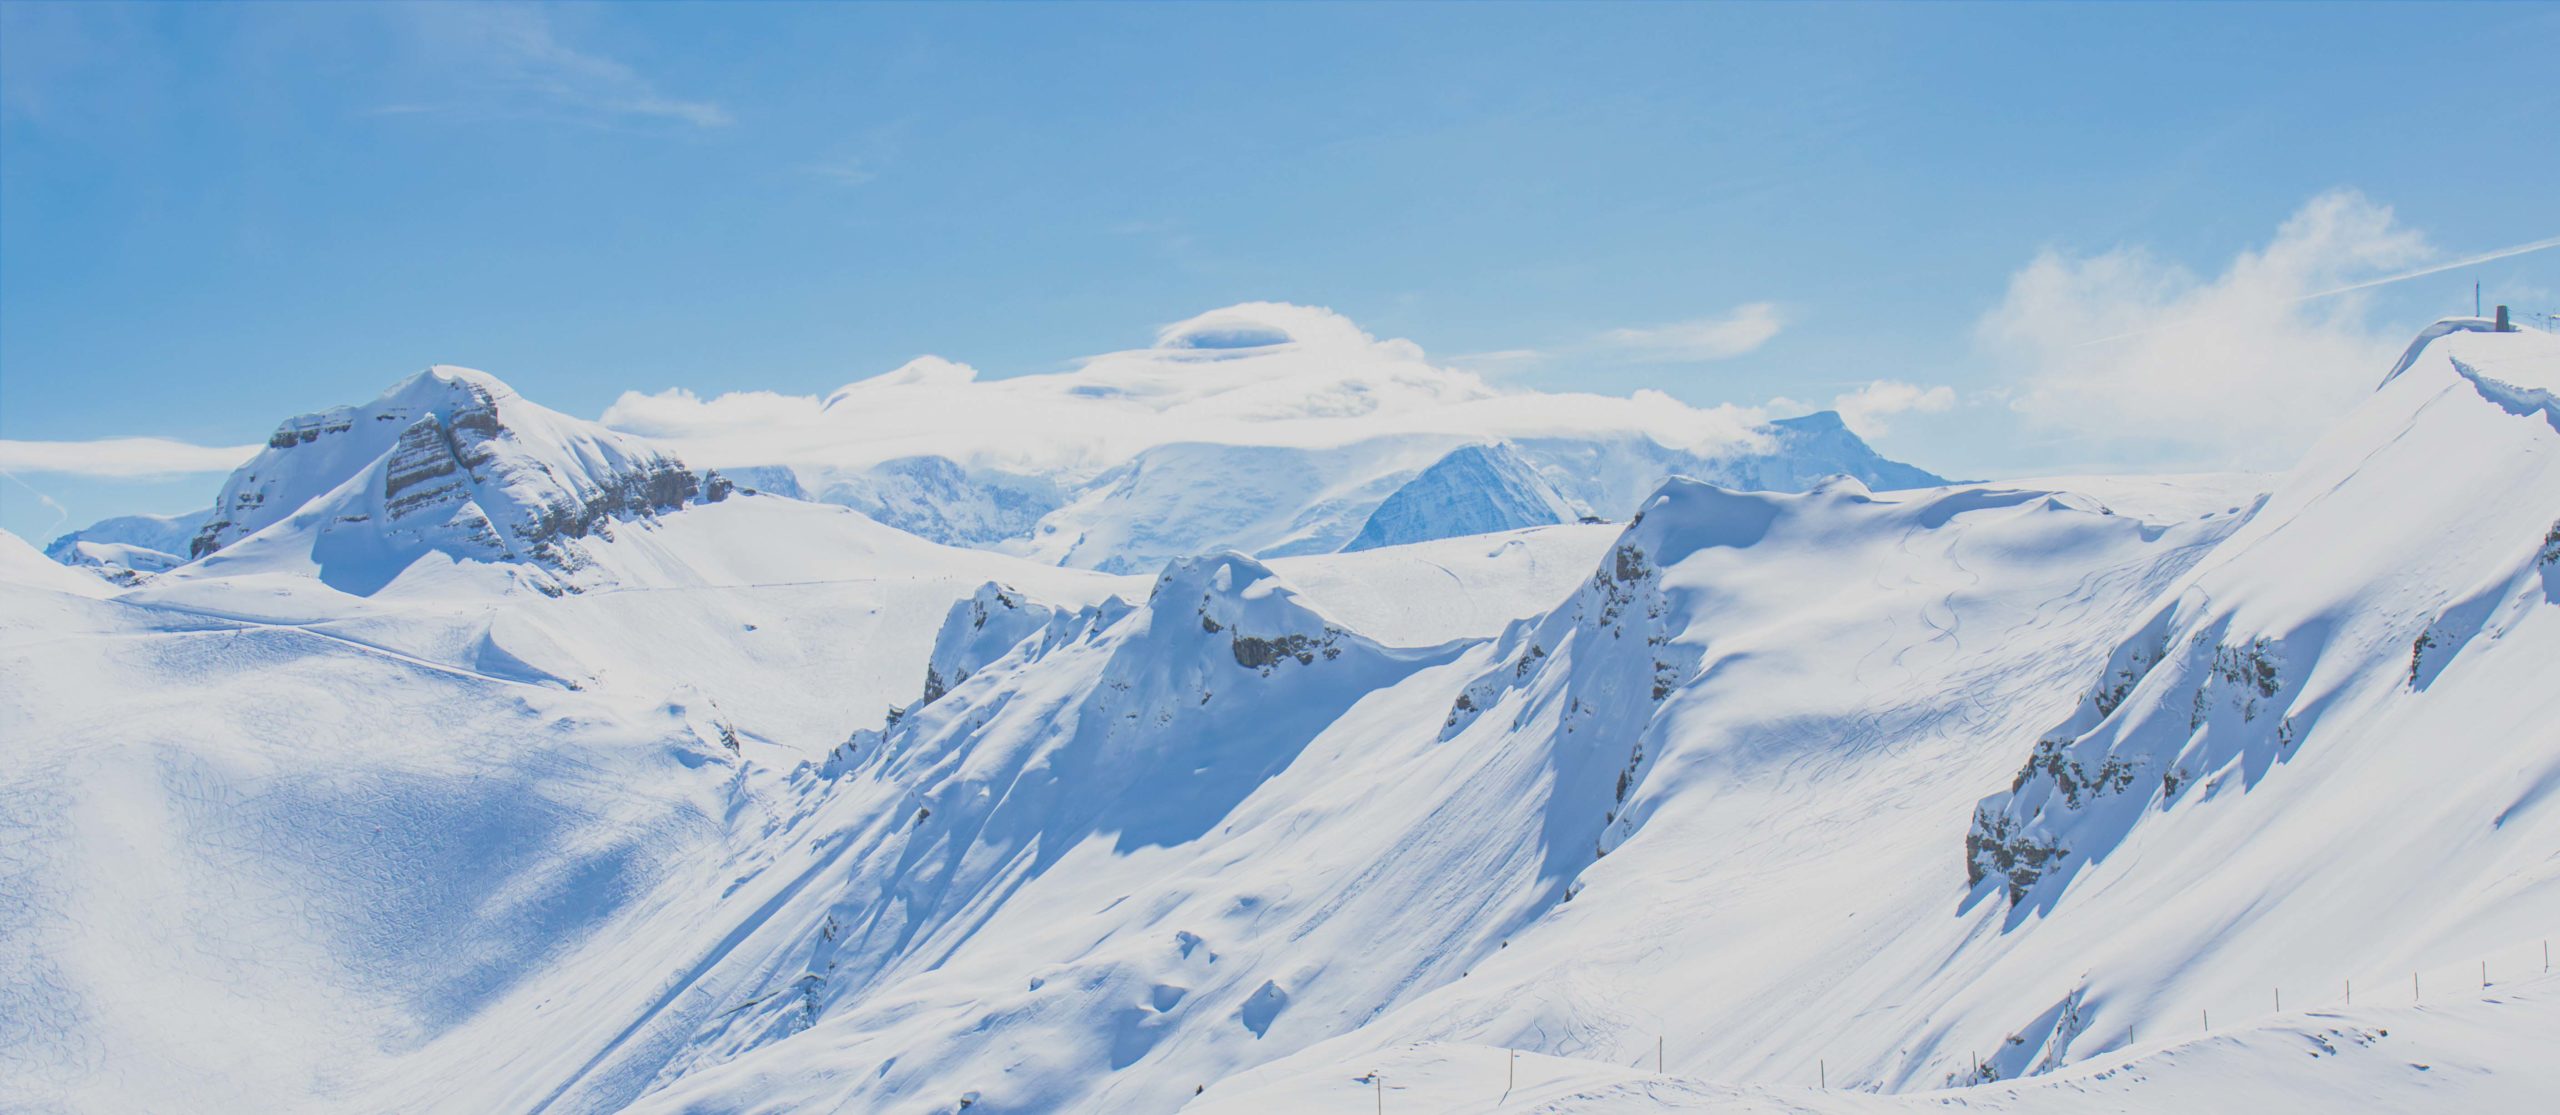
[0,447,1144,1112]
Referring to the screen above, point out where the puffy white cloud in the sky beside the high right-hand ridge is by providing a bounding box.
[1976,192,2432,468]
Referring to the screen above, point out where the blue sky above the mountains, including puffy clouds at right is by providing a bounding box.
[0,3,2560,540]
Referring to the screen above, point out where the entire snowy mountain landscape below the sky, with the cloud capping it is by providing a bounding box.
[0,304,2560,1115]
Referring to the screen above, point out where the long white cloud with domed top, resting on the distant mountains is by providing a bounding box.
[604,302,1761,481]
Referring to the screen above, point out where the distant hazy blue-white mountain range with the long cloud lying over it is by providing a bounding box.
[581,302,1943,562]
